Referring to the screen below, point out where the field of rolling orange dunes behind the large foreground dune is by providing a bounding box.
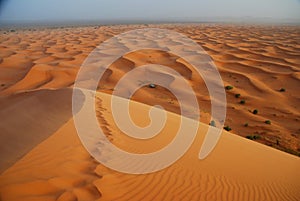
[0,24,300,154]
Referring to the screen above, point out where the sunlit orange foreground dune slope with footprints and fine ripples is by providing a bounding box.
[0,93,300,201]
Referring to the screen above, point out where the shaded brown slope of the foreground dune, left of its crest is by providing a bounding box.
[0,88,72,173]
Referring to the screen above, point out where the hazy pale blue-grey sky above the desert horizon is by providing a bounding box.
[0,0,300,23]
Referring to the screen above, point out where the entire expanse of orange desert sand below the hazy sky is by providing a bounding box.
[0,24,300,201]
